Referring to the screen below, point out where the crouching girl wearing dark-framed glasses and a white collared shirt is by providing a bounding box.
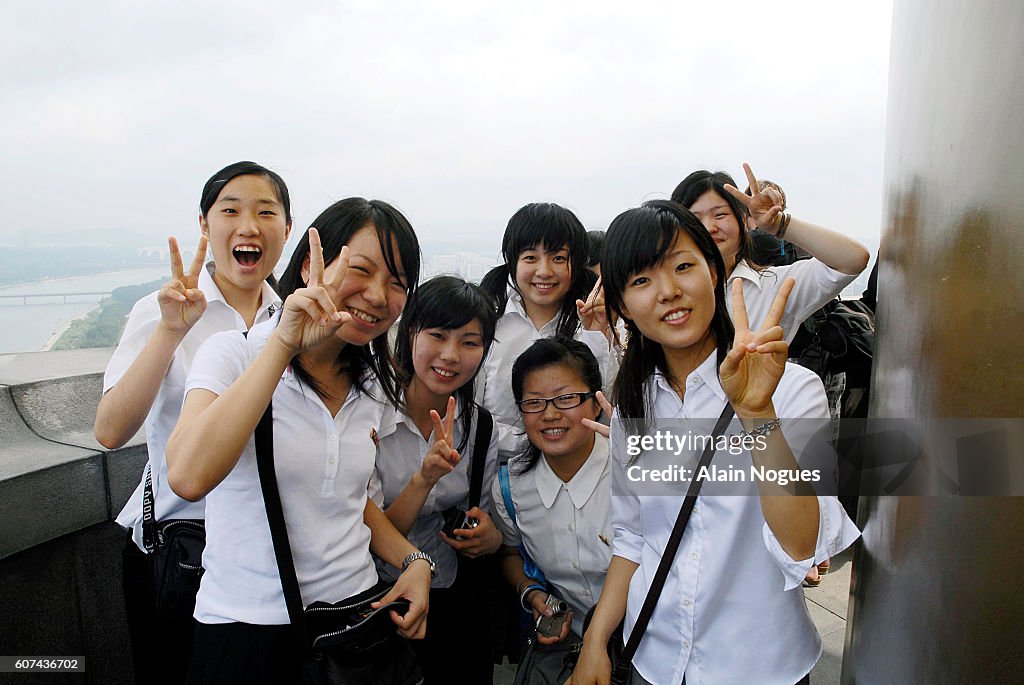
[492,337,611,682]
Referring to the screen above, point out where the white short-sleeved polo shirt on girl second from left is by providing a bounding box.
[185,318,386,626]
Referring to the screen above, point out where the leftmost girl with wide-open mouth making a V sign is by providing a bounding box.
[94,162,292,683]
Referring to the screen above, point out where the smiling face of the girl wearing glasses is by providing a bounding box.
[522,363,601,459]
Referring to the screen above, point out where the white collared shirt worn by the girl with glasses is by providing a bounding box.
[490,435,611,636]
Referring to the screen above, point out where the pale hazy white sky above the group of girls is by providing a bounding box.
[0,0,891,251]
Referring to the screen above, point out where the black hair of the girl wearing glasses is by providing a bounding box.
[509,336,601,473]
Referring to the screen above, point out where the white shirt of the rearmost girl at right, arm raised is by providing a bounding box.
[725,258,858,343]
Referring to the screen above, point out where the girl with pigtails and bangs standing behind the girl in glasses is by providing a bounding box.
[477,203,617,427]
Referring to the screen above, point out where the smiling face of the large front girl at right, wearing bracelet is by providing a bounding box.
[623,229,715,353]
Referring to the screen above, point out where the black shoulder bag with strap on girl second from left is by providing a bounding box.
[255,403,423,685]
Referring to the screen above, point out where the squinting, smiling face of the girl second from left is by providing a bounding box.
[302,224,408,345]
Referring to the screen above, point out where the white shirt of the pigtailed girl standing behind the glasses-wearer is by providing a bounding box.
[476,288,618,427]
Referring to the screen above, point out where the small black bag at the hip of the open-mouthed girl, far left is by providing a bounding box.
[142,466,206,618]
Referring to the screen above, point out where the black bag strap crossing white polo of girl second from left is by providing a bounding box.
[255,401,311,654]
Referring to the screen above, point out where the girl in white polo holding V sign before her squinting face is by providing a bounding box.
[167,198,433,683]
